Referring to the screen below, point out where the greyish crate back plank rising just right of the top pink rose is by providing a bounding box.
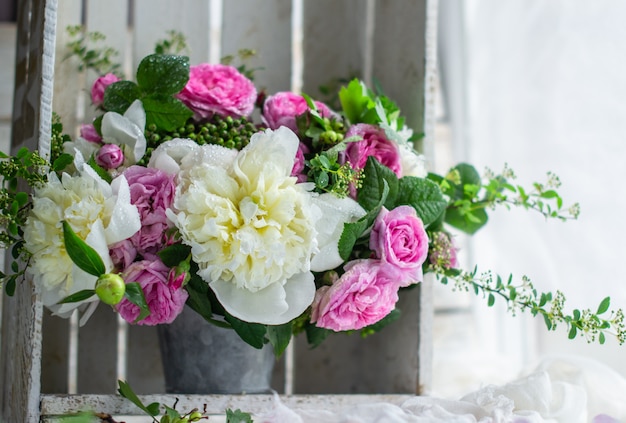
[222,0,292,94]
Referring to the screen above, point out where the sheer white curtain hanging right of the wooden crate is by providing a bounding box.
[440,0,626,388]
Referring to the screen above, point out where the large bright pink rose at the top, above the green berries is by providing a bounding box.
[177,63,257,120]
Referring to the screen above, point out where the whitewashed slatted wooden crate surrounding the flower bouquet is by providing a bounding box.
[0,0,437,421]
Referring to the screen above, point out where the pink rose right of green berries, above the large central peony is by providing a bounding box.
[261,91,334,133]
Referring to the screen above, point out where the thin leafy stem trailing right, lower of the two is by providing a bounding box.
[429,267,626,345]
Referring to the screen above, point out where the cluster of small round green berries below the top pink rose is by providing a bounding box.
[139,115,259,165]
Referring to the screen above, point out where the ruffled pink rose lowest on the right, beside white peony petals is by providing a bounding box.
[311,259,399,332]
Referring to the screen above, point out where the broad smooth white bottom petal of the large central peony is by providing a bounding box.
[209,272,315,325]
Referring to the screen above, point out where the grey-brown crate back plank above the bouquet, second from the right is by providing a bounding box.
[302,0,369,98]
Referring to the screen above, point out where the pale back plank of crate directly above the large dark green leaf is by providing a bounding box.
[133,0,211,69]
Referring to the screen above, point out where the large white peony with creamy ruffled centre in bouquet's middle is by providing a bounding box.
[163,127,354,325]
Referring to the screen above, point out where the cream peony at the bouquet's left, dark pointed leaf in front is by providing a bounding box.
[24,166,141,317]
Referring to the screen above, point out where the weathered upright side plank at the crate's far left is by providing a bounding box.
[0,0,57,422]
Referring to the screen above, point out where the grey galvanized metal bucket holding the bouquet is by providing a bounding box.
[158,307,275,394]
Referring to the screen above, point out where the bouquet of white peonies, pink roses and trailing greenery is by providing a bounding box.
[0,46,626,354]
